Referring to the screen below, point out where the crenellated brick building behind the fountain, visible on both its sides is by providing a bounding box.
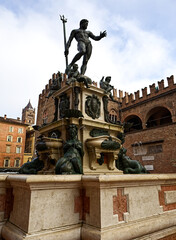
[37,74,176,173]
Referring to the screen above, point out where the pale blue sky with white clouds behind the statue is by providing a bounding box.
[0,0,176,118]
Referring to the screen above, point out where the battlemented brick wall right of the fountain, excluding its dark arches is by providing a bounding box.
[109,76,176,173]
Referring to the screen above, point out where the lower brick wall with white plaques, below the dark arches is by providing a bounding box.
[124,123,176,173]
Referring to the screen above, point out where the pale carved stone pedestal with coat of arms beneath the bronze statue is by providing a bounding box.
[40,82,123,174]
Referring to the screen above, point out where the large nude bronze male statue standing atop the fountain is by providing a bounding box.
[65,19,107,75]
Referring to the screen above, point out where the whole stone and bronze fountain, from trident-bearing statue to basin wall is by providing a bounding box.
[0,16,176,240]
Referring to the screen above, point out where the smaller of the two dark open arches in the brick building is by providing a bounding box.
[124,115,142,132]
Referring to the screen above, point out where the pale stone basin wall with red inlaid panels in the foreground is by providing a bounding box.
[2,174,176,240]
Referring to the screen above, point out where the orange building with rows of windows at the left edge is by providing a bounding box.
[0,115,27,168]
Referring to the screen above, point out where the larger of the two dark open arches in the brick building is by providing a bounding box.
[146,107,172,128]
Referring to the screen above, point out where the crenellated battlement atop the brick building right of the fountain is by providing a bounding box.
[113,75,176,108]
